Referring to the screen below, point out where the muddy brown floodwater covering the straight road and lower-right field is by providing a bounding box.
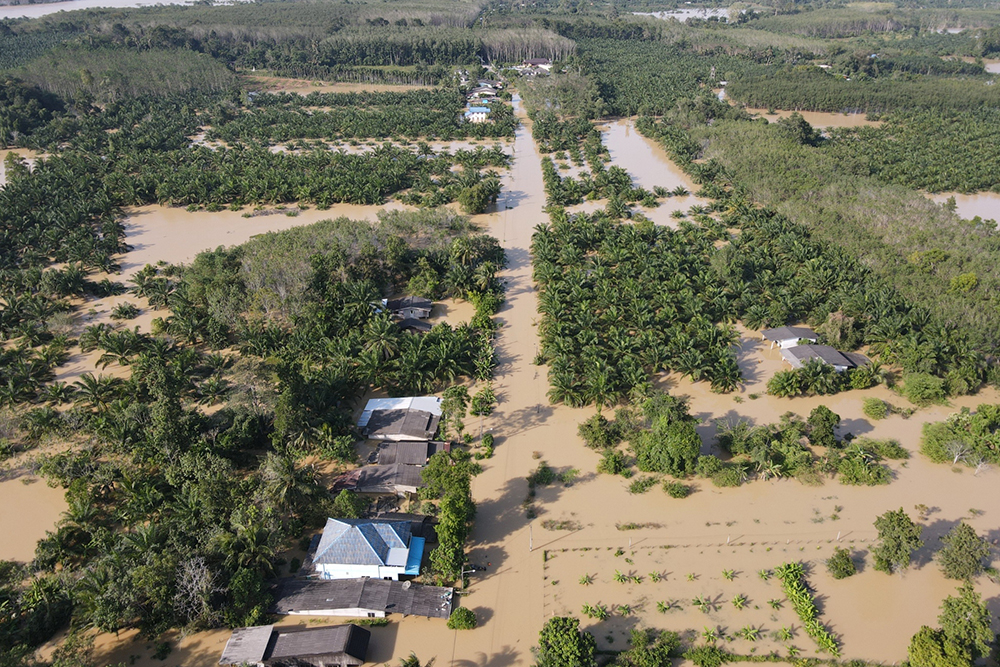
[70,96,1000,667]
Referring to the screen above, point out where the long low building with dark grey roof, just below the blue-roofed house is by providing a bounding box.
[271,579,455,618]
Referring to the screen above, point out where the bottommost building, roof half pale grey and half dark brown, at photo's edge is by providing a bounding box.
[219,625,371,667]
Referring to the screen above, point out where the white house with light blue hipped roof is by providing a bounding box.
[312,516,424,581]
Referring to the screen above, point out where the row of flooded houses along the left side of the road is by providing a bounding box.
[219,388,457,667]
